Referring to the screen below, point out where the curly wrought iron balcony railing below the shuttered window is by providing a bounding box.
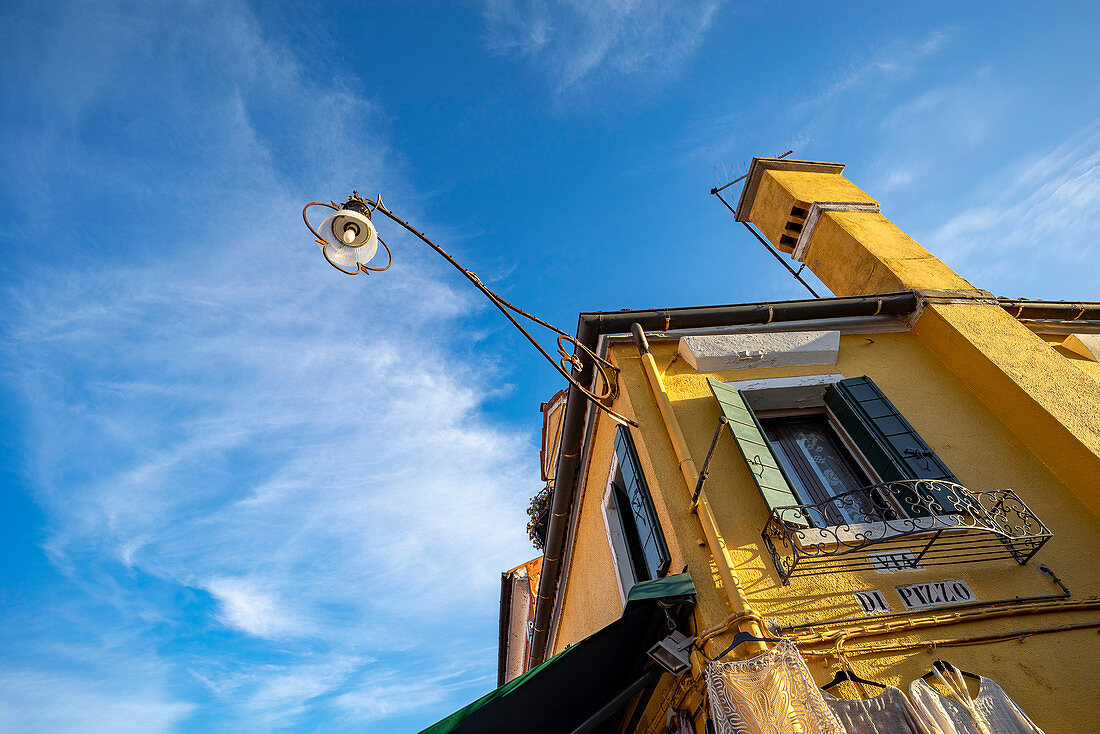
[763,480,1051,583]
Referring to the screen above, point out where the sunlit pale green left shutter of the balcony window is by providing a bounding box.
[706,377,807,527]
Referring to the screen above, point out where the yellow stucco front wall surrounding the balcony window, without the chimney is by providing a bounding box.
[618,332,1100,731]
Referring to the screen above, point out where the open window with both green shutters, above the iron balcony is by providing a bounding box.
[708,375,967,527]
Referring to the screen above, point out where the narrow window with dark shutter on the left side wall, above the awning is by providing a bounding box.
[604,426,671,600]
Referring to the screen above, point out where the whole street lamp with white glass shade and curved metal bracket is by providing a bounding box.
[301,191,638,426]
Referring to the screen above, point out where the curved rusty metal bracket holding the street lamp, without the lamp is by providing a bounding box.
[301,191,638,428]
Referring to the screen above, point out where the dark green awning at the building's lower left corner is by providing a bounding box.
[421,573,695,734]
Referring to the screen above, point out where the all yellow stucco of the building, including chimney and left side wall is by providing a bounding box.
[545,158,1100,732]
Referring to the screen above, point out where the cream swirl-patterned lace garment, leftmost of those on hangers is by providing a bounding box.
[706,640,845,734]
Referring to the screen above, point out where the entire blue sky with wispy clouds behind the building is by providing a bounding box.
[0,0,1100,732]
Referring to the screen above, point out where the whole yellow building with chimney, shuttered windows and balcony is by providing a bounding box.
[424,158,1100,733]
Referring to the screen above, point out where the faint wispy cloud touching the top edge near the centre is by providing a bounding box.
[482,0,723,94]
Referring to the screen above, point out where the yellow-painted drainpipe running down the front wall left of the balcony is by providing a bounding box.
[630,321,767,655]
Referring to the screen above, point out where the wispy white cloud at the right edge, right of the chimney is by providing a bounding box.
[928,124,1100,298]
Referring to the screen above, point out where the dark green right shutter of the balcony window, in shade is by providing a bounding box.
[825,375,959,516]
